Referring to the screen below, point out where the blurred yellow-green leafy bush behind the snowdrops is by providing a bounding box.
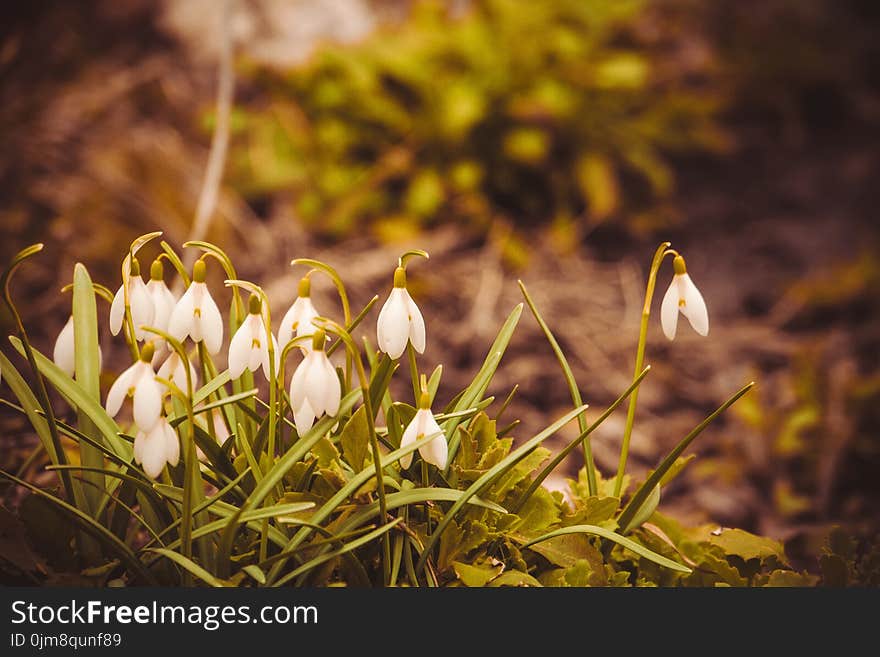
[229,0,726,239]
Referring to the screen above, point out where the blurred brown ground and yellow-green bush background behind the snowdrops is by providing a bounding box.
[0,0,880,569]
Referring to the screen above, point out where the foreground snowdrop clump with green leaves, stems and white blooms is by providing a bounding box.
[0,238,824,587]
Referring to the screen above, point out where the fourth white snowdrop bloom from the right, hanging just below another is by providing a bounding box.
[290,328,342,435]
